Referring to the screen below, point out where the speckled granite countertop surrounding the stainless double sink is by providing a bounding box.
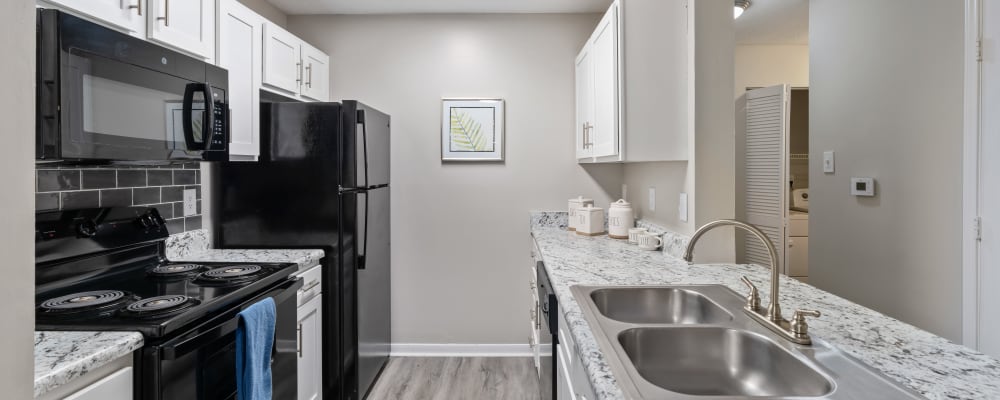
[531,212,1000,400]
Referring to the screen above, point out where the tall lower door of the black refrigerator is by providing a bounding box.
[357,187,391,393]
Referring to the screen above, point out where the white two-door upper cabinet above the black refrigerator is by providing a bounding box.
[262,23,330,101]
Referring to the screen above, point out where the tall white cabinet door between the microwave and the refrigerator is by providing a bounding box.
[219,0,265,160]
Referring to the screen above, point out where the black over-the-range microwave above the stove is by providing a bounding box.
[35,9,229,163]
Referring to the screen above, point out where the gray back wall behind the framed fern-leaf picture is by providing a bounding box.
[288,15,622,344]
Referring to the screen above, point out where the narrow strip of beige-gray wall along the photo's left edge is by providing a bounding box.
[0,0,35,399]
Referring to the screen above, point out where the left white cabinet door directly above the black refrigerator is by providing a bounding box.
[261,23,302,96]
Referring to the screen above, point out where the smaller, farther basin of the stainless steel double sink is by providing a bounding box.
[590,287,733,324]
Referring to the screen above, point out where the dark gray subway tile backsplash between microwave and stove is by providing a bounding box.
[35,163,202,233]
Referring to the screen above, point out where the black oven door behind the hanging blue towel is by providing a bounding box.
[137,279,302,400]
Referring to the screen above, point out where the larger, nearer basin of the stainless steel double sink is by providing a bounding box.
[618,327,833,397]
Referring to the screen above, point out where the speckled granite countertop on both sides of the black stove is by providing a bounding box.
[35,229,324,397]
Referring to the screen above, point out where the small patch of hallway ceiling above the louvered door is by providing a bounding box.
[736,0,809,44]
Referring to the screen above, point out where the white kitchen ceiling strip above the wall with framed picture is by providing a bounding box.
[268,0,611,15]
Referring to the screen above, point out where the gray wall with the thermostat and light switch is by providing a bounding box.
[809,0,964,341]
